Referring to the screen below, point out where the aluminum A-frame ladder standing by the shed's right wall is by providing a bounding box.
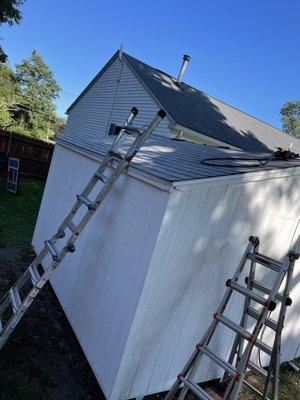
[165,236,299,400]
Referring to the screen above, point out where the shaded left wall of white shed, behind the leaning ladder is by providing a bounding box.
[33,145,169,398]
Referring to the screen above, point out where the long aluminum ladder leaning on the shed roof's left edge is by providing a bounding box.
[0,107,166,349]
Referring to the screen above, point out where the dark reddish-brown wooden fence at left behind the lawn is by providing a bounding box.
[0,130,54,179]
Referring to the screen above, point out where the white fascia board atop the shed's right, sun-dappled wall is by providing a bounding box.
[173,167,300,191]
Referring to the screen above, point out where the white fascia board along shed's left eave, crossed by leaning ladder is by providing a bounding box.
[56,138,172,192]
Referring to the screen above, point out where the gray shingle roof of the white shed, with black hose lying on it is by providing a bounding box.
[57,133,300,182]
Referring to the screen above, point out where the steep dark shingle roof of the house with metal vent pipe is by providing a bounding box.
[123,53,300,153]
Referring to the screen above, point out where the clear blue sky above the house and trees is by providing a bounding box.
[0,0,300,127]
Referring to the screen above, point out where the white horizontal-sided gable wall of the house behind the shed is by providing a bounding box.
[65,59,171,136]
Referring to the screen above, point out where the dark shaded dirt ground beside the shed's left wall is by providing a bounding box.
[0,243,104,400]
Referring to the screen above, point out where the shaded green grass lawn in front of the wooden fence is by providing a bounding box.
[0,178,45,248]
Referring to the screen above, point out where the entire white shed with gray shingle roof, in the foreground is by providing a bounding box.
[33,132,300,400]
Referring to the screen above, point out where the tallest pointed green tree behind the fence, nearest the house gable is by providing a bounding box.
[16,50,60,138]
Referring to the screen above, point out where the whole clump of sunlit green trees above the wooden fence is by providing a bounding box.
[0,50,65,139]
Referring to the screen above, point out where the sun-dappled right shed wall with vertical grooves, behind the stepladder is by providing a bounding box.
[112,175,300,400]
